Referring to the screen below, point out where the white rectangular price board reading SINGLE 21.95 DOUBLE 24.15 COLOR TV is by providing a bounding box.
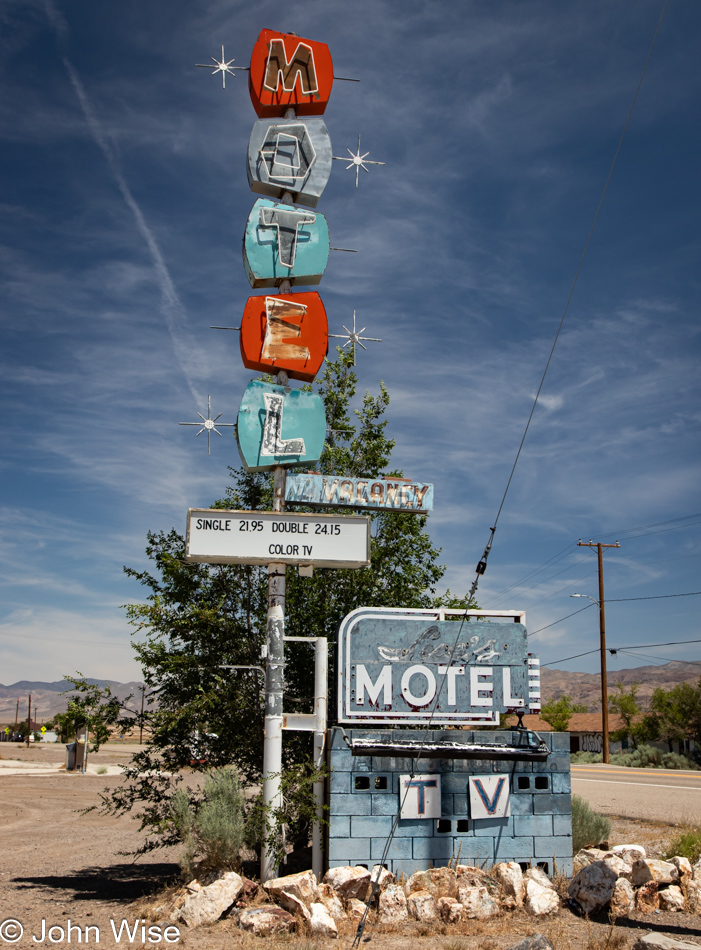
[185,508,370,568]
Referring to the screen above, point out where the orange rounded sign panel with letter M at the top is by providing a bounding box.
[248,30,333,119]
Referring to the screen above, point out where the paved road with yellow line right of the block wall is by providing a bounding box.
[572,765,701,825]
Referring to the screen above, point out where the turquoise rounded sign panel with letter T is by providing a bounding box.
[243,198,329,287]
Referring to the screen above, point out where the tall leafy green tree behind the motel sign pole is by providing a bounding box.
[106,352,464,849]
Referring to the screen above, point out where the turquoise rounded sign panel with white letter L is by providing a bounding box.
[236,379,326,472]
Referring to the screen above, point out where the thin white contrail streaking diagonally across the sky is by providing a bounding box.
[45,0,206,403]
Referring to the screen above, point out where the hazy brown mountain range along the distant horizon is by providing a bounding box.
[0,660,701,726]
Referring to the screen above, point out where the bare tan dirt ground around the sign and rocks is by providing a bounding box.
[0,744,701,950]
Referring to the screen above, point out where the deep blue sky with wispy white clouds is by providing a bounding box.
[0,0,701,683]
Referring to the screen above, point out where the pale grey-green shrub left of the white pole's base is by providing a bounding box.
[170,769,245,878]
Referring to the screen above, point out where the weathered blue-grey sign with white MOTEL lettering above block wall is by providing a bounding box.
[337,607,540,726]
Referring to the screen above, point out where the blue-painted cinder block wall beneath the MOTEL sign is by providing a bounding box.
[328,727,572,874]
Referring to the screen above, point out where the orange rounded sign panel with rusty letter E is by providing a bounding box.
[240,293,329,383]
